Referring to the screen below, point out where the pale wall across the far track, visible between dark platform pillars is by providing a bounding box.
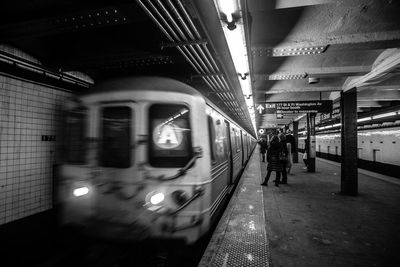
[298,121,400,178]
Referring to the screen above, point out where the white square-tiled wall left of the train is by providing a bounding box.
[0,74,70,224]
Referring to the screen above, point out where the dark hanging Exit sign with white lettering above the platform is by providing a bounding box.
[265,100,332,114]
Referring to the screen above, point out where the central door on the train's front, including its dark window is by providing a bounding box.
[95,103,136,223]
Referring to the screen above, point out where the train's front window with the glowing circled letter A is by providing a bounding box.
[149,104,192,167]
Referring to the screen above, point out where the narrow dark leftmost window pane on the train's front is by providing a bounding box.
[65,108,86,164]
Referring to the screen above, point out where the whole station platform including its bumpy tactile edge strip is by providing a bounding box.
[199,151,400,267]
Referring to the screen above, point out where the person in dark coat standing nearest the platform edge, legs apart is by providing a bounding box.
[261,135,283,186]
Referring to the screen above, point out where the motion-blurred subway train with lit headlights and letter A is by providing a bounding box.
[57,77,256,244]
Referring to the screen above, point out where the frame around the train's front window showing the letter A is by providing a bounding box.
[147,102,193,168]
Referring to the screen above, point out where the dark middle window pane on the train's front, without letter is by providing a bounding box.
[100,106,132,168]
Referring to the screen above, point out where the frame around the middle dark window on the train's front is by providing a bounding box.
[98,104,137,169]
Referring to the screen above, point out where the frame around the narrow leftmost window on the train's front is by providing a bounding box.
[63,106,89,165]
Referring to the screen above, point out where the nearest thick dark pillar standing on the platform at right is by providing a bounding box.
[340,88,358,196]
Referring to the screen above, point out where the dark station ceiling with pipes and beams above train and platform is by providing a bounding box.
[0,0,400,136]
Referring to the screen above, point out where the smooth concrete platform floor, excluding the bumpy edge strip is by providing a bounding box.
[255,154,400,267]
